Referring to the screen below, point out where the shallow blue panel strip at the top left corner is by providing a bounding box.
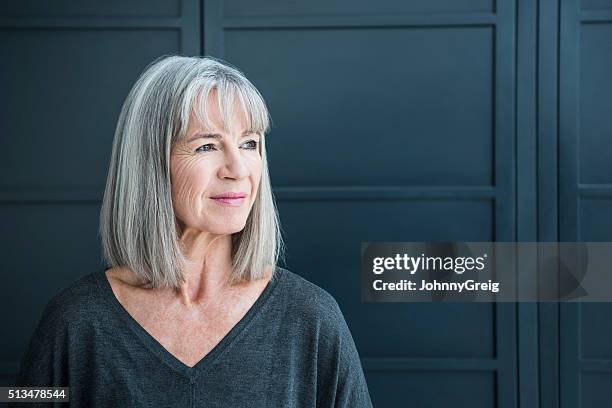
[0,0,180,17]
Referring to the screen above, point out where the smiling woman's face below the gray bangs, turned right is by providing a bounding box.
[170,90,262,235]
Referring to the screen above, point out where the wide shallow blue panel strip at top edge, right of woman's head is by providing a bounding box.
[223,0,494,17]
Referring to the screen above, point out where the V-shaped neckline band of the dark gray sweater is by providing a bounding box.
[96,267,284,383]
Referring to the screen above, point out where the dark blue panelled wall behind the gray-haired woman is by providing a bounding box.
[0,0,612,408]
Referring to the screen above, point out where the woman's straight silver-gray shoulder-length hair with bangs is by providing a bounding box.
[100,56,284,288]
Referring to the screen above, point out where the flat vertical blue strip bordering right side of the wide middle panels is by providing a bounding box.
[492,1,519,408]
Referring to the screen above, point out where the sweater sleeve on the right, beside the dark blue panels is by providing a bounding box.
[317,295,372,408]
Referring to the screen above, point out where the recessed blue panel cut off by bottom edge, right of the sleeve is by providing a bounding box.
[366,371,497,408]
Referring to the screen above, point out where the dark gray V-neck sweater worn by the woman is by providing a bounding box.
[16,267,372,408]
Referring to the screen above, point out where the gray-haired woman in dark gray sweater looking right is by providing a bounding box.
[17,56,372,407]
